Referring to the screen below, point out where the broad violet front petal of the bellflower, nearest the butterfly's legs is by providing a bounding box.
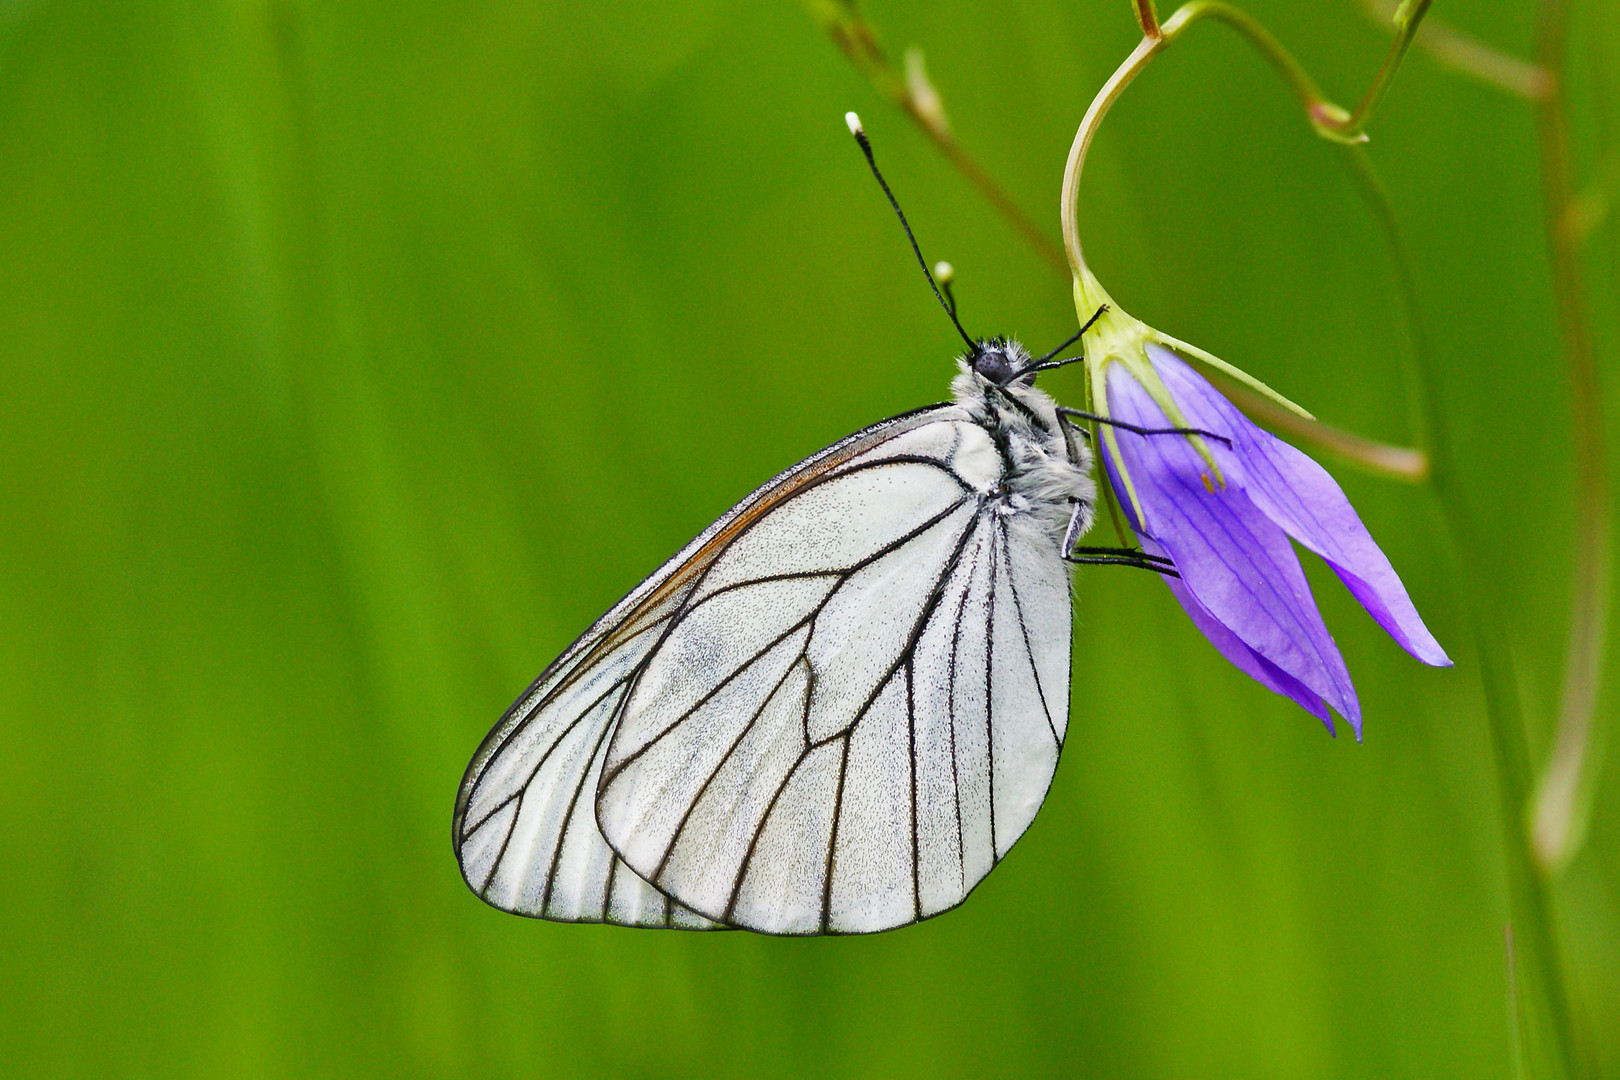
[1103,366,1361,737]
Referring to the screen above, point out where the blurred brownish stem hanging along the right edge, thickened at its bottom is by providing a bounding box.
[1533,0,1610,873]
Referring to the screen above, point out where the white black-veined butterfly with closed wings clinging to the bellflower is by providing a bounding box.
[452,113,1198,934]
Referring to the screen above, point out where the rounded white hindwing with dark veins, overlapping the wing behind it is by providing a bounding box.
[596,415,1071,934]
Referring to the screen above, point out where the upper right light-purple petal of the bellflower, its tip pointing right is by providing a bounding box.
[1147,343,1452,667]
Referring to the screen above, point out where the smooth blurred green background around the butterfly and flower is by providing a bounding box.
[0,0,1620,1077]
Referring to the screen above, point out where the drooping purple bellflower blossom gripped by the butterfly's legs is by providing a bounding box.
[1098,342,1452,738]
